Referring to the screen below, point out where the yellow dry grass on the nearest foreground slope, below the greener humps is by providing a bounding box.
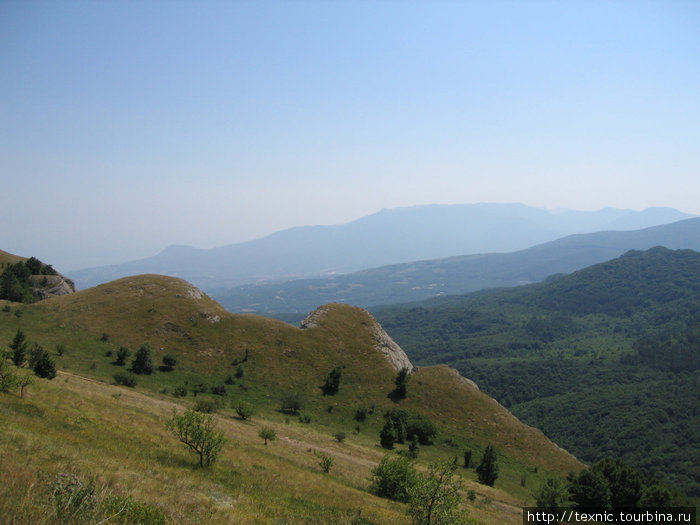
[0,373,540,524]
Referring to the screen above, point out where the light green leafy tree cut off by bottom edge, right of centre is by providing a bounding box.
[407,460,466,525]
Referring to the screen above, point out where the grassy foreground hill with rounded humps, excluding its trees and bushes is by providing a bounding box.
[0,275,582,524]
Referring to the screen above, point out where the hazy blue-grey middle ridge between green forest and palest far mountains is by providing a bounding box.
[211,218,700,313]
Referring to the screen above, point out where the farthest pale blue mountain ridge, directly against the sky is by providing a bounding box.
[69,204,690,290]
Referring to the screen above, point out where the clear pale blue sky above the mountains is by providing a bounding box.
[0,0,700,271]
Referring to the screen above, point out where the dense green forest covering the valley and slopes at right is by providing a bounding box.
[374,247,700,498]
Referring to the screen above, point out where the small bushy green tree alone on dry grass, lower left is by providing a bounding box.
[166,409,226,467]
